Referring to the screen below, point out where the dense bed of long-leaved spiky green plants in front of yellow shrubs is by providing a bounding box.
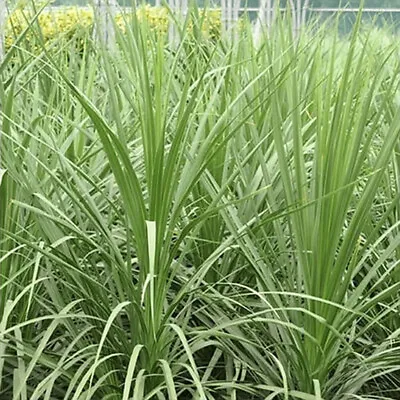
[0,3,400,400]
